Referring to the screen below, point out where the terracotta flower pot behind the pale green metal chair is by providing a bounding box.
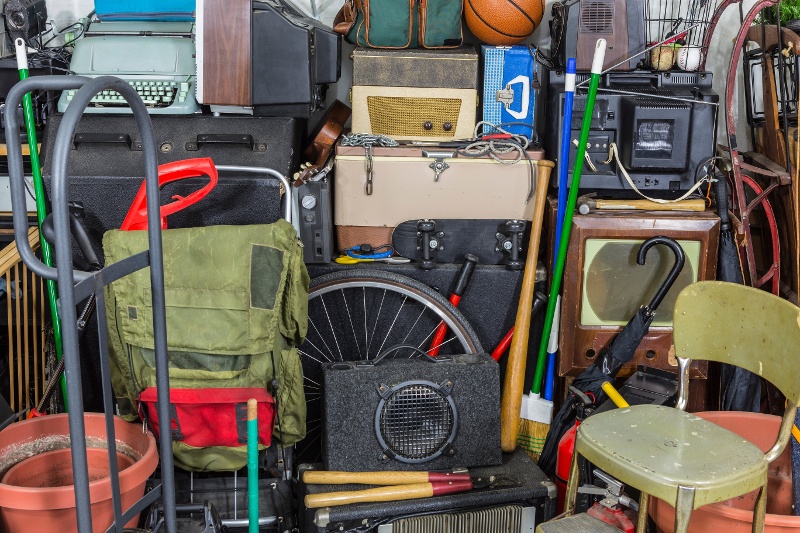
[650,411,800,533]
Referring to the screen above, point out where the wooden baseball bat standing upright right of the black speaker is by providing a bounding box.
[500,160,555,452]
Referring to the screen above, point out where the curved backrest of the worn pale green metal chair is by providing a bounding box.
[673,281,800,405]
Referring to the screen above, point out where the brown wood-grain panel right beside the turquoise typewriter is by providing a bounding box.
[203,0,253,106]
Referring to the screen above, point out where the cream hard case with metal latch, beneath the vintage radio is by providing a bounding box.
[333,140,544,250]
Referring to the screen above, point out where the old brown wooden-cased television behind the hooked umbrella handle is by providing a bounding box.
[551,205,719,378]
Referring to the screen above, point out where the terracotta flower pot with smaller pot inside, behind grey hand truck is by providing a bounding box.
[0,413,158,533]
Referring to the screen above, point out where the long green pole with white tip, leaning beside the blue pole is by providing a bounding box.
[531,39,606,394]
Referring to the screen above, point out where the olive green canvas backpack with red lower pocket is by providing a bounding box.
[103,220,309,471]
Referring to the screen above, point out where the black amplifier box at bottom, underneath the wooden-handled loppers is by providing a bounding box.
[299,448,556,533]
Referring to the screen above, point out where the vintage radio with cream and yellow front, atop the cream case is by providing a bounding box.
[350,47,478,141]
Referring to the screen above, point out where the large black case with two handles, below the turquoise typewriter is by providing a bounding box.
[42,115,300,259]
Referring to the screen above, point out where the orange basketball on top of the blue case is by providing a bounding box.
[464,0,544,46]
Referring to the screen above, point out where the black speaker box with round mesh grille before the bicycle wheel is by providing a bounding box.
[322,354,502,471]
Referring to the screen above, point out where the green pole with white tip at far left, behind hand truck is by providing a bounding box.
[14,39,67,411]
